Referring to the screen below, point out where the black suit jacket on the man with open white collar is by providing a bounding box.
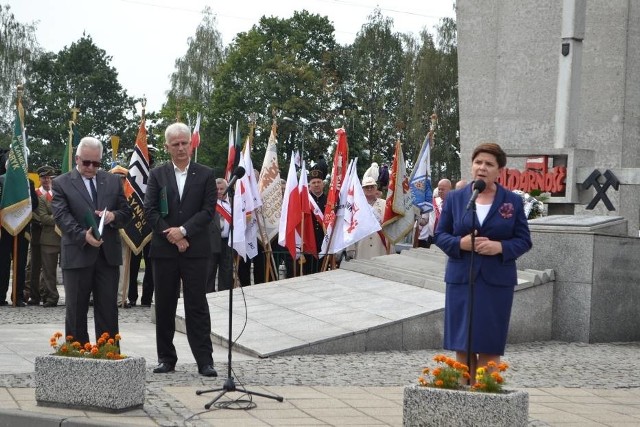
[144,161,217,258]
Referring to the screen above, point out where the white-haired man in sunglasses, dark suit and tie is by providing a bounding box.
[51,137,131,343]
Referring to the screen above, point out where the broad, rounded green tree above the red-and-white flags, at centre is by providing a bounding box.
[206,11,338,172]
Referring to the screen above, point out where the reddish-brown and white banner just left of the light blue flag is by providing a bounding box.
[382,140,418,243]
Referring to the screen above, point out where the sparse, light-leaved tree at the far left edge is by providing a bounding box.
[0,4,40,140]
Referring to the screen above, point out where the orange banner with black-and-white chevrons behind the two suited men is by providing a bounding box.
[120,115,152,255]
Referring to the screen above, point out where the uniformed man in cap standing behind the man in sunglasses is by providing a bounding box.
[35,166,60,307]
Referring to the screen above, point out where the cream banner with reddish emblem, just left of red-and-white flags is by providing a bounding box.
[258,125,282,244]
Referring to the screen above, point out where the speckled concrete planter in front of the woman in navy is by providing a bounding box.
[403,385,529,427]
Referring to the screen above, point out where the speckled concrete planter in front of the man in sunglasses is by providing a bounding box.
[35,355,146,412]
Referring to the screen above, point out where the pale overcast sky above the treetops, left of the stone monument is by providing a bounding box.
[5,0,455,111]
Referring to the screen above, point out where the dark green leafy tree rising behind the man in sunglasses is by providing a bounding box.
[25,35,139,171]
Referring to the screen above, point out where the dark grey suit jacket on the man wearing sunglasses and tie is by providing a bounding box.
[51,169,131,268]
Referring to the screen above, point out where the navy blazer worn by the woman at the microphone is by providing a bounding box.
[435,183,532,286]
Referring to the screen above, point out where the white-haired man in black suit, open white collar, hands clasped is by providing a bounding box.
[144,123,218,377]
